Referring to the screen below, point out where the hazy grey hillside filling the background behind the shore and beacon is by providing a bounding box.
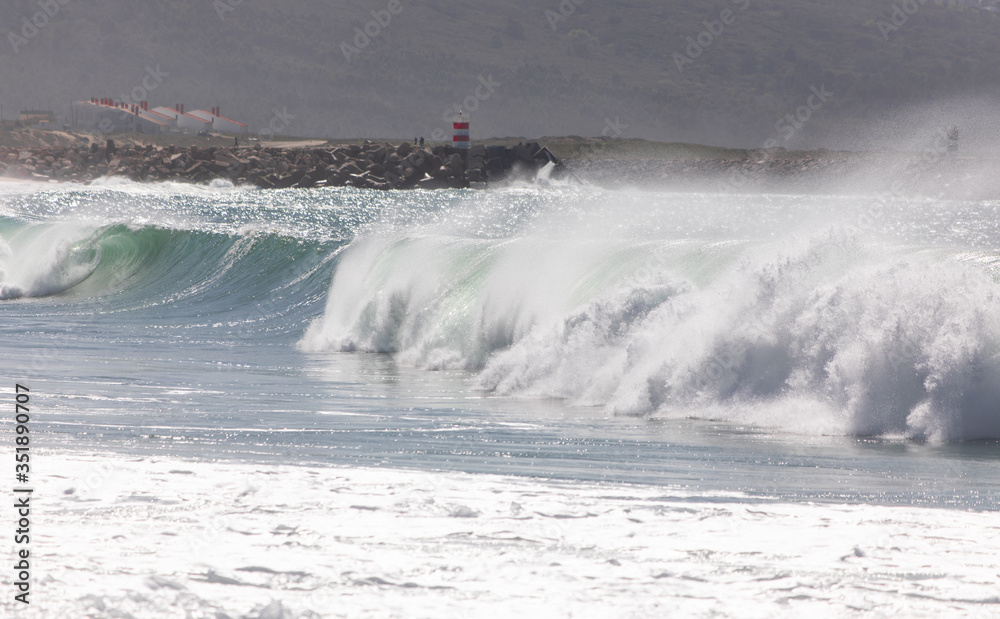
[0,0,1000,147]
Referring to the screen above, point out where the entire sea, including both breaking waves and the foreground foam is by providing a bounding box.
[0,180,1000,619]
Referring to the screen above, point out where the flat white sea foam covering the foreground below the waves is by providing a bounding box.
[9,452,1000,619]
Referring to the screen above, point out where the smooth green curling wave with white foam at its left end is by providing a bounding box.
[0,222,326,318]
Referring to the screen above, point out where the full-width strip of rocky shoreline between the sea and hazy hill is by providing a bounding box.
[0,131,1000,199]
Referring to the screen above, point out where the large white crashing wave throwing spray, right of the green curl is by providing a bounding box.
[300,192,1000,440]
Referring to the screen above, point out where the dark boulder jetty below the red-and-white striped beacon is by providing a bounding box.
[0,140,561,189]
